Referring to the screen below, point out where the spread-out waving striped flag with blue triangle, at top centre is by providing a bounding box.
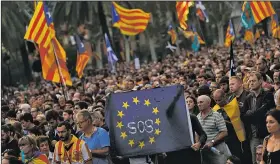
[112,2,151,35]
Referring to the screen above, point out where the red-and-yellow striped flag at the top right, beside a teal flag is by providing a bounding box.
[250,1,275,23]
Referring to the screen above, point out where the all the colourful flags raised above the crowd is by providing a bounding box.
[24,1,280,86]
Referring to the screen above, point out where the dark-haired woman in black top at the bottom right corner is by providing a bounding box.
[260,109,280,164]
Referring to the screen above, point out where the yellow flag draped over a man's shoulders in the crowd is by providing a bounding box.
[213,98,246,142]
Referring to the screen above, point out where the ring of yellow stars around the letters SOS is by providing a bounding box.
[116,97,161,149]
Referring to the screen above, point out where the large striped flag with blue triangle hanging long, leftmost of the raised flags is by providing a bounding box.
[24,1,72,85]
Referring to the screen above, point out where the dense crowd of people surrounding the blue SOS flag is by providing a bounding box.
[1,37,280,164]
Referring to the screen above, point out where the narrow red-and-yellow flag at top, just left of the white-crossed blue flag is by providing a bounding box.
[176,1,194,30]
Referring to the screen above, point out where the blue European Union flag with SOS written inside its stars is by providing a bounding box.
[106,85,193,157]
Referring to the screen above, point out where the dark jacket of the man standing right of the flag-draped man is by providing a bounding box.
[241,89,275,139]
